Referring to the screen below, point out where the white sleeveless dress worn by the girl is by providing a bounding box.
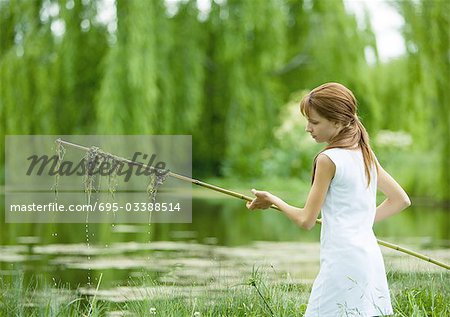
[305,148,392,317]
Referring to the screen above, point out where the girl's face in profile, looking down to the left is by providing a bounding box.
[305,109,341,143]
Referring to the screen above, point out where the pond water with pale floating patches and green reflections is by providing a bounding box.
[0,193,450,302]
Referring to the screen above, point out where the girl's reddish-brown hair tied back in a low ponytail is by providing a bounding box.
[300,83,378,186]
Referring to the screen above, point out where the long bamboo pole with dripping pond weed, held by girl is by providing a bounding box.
[56,139,450,270]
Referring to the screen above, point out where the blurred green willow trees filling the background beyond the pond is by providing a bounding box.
[0,0,450,200]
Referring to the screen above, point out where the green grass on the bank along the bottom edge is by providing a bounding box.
[0,269,450,317]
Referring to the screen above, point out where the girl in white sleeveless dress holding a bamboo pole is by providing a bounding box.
[247,83,411,317]
